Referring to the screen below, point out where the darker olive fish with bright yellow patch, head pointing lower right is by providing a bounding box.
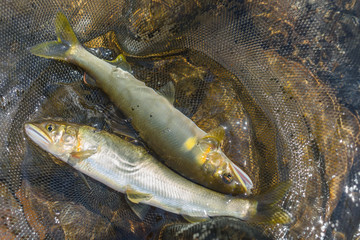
[30,12,253,195]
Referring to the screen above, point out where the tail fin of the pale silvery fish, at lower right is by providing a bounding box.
[249,181,291,224]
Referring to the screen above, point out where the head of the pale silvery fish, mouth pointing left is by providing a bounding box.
[24,121,80,161]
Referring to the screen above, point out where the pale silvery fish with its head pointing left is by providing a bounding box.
[24,120,291,224]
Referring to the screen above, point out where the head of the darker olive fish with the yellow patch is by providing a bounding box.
[200,138,253,195]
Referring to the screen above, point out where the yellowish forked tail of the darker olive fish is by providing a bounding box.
[30,12,80,61]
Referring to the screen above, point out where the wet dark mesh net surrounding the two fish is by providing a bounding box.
[0,0,360,239]
